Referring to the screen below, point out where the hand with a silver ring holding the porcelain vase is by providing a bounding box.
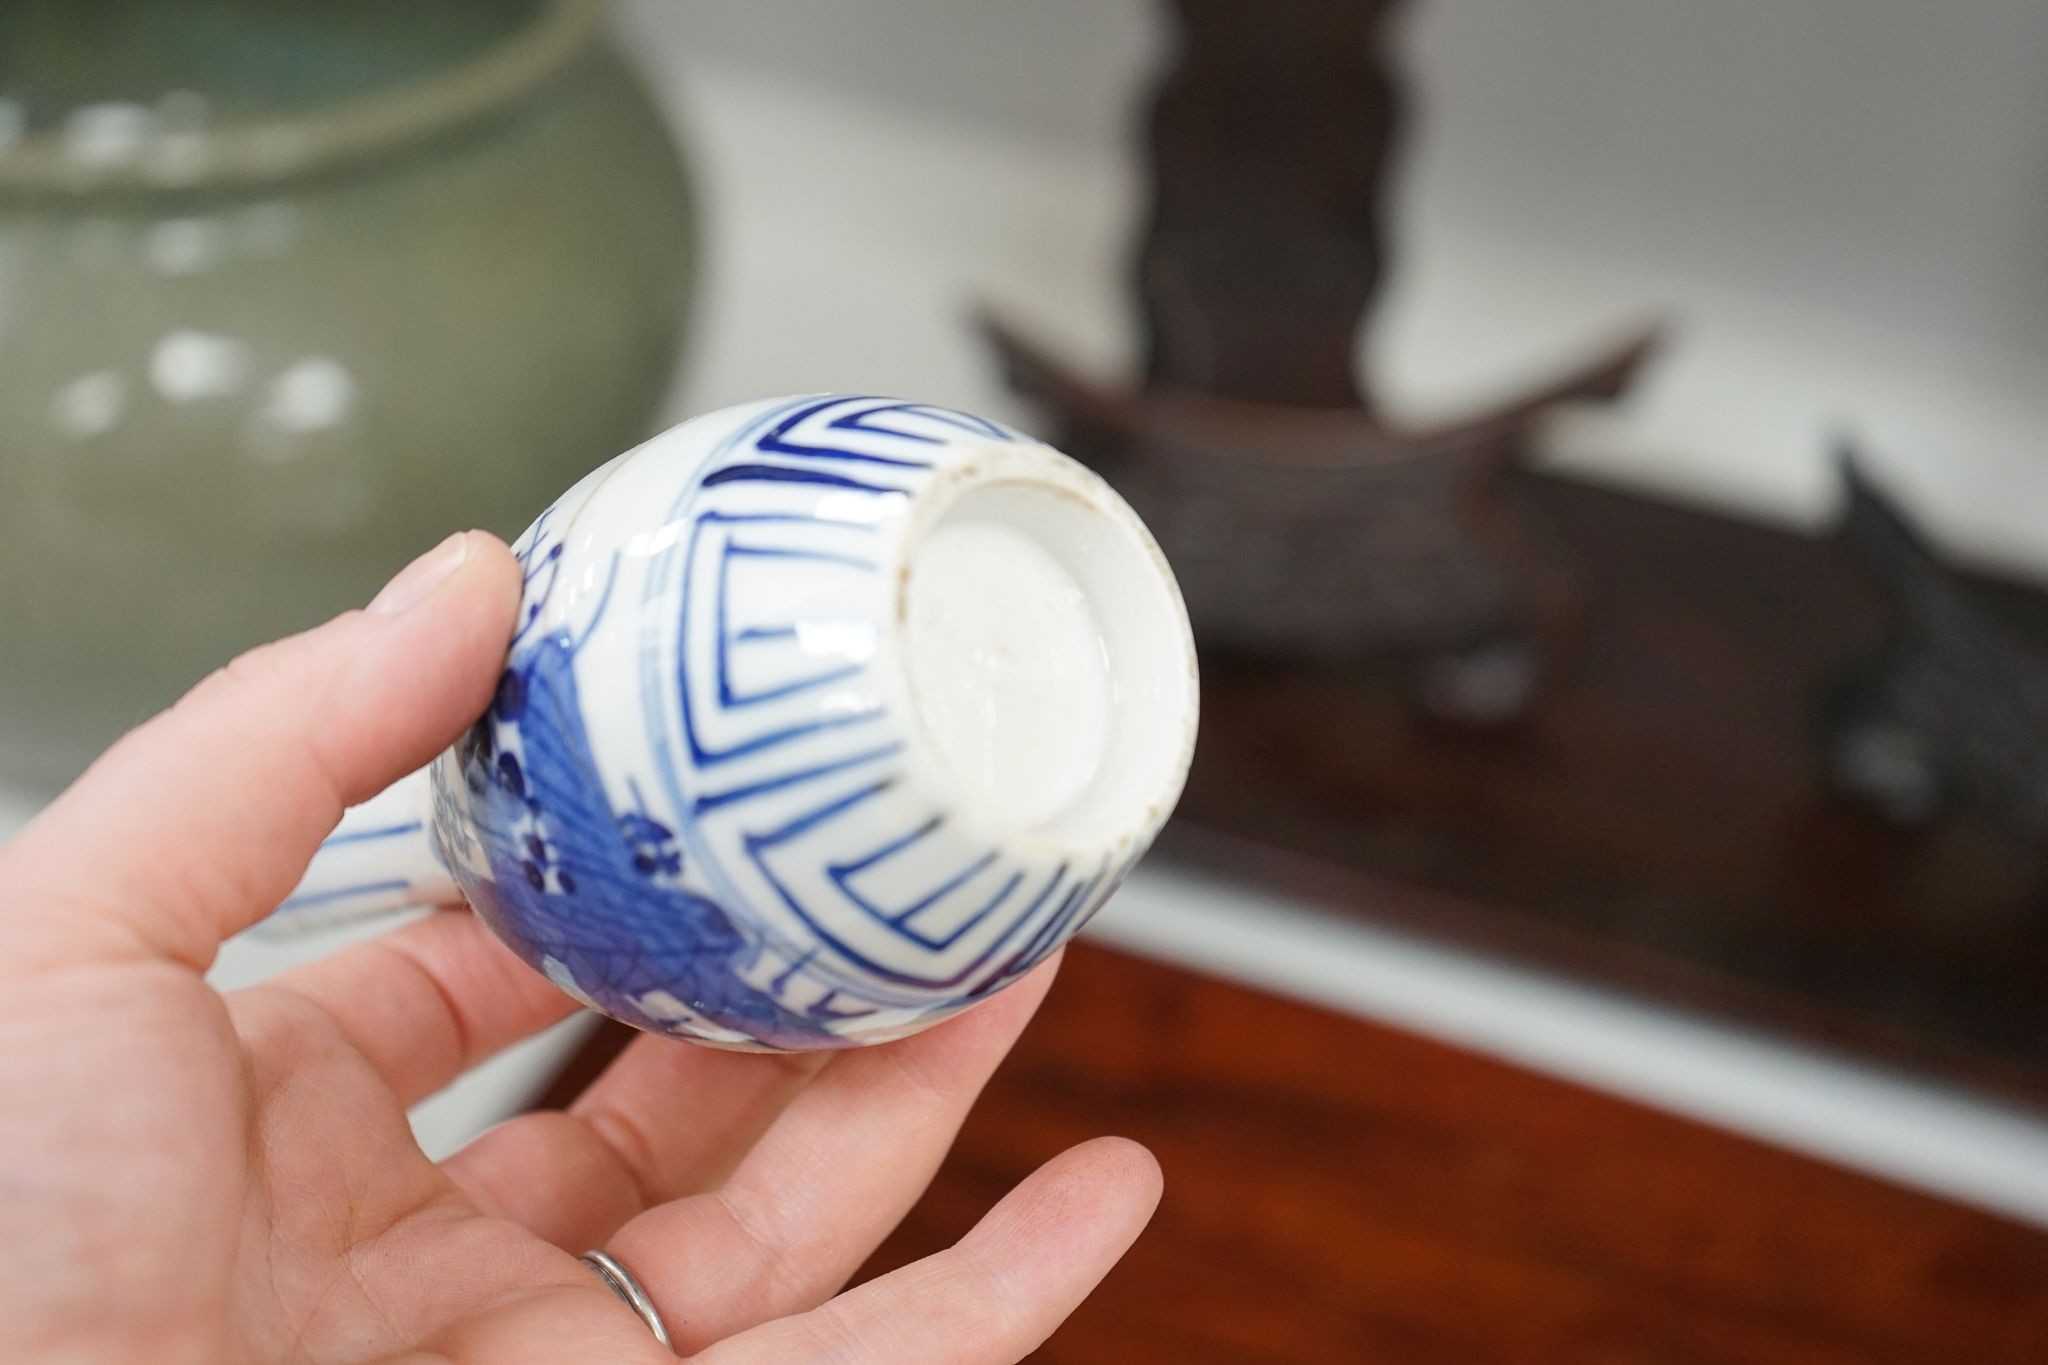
[0,532,1159,1365]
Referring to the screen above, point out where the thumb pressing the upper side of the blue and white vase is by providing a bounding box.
[0,530,520,970]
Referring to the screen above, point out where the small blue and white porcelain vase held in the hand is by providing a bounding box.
[281,395,1196,1050]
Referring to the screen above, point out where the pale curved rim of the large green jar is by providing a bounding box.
[0,0,606,194]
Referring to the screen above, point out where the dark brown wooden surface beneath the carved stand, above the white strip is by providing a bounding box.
[1161,475,2048,1105]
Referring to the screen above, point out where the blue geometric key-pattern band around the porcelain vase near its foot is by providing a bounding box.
[647,395,1126,1031]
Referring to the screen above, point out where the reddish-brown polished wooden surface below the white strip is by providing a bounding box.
[839,945,2048,1365]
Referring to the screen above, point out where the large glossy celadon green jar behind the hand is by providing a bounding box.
[0,0,692,792]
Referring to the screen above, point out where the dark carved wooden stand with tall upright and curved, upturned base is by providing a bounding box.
[987,0,1653,720]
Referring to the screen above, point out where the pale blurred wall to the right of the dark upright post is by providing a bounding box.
[1386,0,2048,569]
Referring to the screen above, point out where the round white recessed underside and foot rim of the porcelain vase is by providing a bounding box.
[895,446,1198,860]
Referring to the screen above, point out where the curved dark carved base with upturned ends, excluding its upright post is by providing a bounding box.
[983,319,1657,722]
